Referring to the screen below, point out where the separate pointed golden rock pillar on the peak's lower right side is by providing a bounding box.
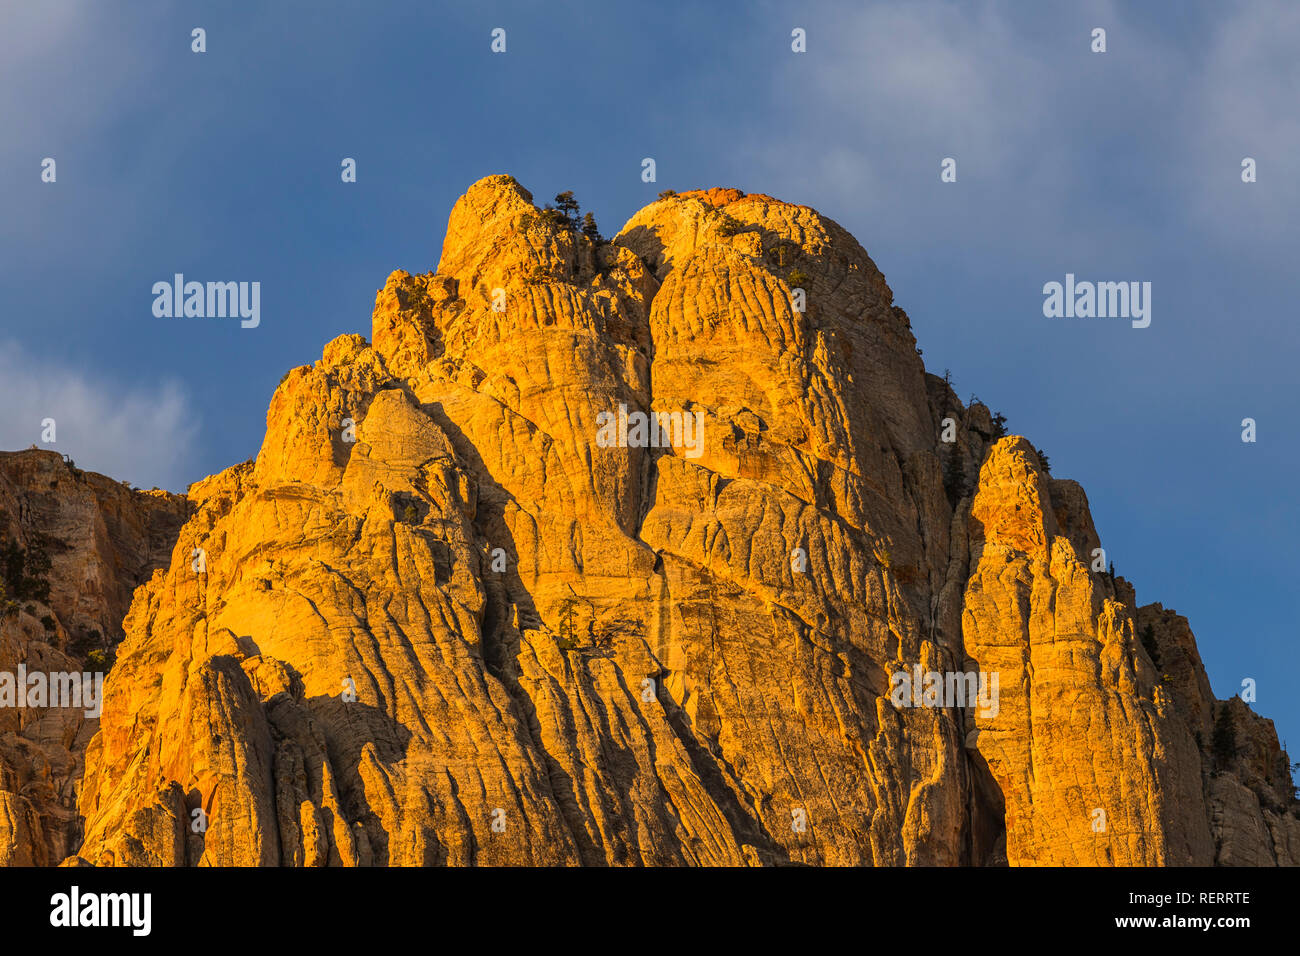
[962,437,1213,866]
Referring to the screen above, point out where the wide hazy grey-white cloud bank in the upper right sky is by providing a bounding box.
[736,0,1300,261]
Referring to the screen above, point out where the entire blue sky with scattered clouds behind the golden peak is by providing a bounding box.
[0,0,1300,750]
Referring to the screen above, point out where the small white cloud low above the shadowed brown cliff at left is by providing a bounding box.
[0,342,198,490]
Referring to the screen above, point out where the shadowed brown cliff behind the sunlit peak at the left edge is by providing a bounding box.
[0,450,187,866]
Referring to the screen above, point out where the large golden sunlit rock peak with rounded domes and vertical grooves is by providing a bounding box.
[9,176,1300,866]
